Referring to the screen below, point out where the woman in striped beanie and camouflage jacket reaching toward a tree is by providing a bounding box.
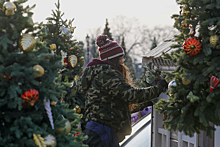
[81,35,168,147]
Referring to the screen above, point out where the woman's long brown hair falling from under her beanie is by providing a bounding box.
[107,58,138,112]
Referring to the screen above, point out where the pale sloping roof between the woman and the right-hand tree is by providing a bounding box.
[143,38,177,58]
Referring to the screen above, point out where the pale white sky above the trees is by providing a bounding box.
[25,0,179,40]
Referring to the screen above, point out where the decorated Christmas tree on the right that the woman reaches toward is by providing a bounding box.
[156,0,220,137]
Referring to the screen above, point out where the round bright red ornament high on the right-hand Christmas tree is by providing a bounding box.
[183,37,202,56]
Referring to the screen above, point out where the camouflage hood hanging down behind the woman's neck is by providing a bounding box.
[81,59,114,91]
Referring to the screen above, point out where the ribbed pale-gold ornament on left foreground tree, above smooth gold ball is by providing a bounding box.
[19,34,36,51]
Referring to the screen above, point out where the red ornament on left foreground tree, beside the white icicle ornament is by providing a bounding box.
[22,89,39,106]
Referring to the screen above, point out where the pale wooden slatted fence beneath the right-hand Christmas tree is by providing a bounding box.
[151,109,220,147]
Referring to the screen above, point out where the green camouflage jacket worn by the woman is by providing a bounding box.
[81,59,162,140]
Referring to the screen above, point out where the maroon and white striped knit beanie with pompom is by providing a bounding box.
[96,35,124,60]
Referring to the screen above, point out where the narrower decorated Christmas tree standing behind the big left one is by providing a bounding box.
[43,1,84,108]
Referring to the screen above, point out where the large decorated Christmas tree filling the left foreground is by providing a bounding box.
[0,0,85,147]
